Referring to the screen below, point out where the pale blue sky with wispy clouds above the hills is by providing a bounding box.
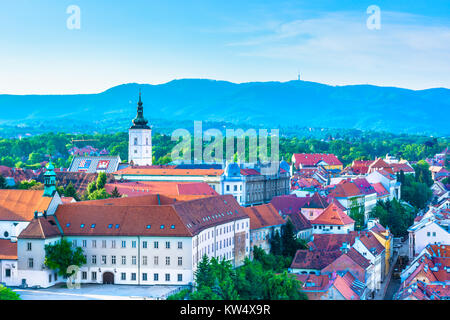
[0,0,450,94]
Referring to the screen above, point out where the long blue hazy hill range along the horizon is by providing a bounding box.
[0,79,450,135]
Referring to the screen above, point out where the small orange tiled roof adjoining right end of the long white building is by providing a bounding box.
[244,203,285,230]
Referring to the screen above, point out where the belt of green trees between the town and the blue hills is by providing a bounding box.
[0,130,449,169]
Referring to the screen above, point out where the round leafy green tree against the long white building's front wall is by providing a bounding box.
[44,238,86,276]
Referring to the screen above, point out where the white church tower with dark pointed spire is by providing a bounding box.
[128,90,152,166]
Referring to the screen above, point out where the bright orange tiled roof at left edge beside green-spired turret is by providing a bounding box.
[0,189,53,221]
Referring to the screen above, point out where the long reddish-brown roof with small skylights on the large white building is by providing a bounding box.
[51,195,248,237]
